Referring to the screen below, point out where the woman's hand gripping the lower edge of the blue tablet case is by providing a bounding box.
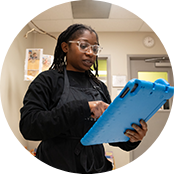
[125,120,147,143]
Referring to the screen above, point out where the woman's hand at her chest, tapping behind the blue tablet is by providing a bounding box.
[88,100,109,119]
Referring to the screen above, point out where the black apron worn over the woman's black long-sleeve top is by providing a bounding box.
[33,69,112,174]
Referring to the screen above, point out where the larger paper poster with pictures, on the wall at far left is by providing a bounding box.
[24,48,43,81]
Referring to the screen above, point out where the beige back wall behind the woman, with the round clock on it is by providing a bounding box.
[28,32,174,171]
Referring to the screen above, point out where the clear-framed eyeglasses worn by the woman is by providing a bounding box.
[69,41,103,56]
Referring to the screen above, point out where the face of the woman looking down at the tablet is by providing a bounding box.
[62,30,98,72]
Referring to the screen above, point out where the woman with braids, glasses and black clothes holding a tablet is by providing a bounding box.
[20,24,147,174]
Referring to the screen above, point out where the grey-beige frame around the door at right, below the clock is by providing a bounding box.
[127,54,174,174]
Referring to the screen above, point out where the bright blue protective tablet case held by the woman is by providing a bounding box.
[81,79,174,145]
